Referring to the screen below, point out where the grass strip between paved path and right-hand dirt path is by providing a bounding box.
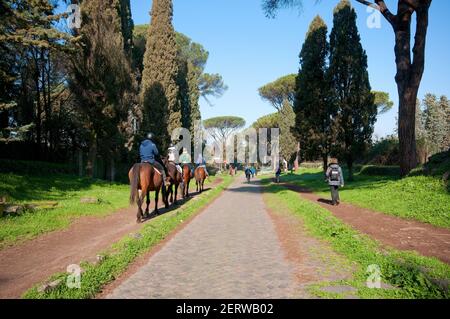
[264,181,450,299]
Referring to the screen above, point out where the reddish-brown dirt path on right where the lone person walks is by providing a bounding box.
[282,184,450,264]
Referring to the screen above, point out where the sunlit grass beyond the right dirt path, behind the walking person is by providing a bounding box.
[281,169,450,228]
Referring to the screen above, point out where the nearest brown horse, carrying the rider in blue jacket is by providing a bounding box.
[128,163,169,223]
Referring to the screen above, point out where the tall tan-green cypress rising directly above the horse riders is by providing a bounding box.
[141,0,182,150]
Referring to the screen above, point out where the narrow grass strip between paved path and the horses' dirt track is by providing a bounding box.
[23,176,233,299]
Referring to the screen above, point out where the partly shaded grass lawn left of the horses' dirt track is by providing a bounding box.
[0,174,129,248]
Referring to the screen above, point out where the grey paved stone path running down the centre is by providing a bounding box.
[107,178,304,299]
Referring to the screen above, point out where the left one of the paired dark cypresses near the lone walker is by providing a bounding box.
[294,16,333,169]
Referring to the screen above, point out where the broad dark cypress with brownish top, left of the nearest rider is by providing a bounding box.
[69,0,133,178]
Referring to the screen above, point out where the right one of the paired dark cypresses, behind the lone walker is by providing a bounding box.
[328,0,377,180]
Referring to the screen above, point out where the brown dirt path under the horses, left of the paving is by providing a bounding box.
[0,180,221,299]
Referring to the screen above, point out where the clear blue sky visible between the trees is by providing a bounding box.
[131,0,450,137]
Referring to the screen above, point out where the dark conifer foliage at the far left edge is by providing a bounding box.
[0,0,71,145]
